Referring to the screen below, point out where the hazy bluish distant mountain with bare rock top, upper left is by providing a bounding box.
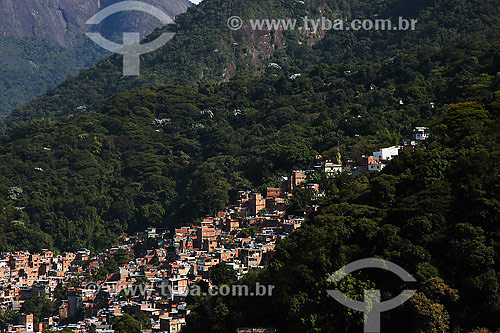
[0,0,190,118]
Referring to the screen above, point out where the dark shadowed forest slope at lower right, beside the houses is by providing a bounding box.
[186,100,500,332]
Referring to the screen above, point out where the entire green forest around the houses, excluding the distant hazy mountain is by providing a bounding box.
[0,0,500,333]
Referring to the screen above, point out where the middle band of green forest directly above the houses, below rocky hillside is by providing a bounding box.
[0,31,500,250]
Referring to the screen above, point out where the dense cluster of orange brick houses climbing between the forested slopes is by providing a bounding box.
[0,127,428,333]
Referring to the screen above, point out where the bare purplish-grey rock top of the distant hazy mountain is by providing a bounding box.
[0,0,191,47]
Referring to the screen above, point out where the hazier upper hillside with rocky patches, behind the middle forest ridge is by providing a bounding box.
[6,0,500,124]
